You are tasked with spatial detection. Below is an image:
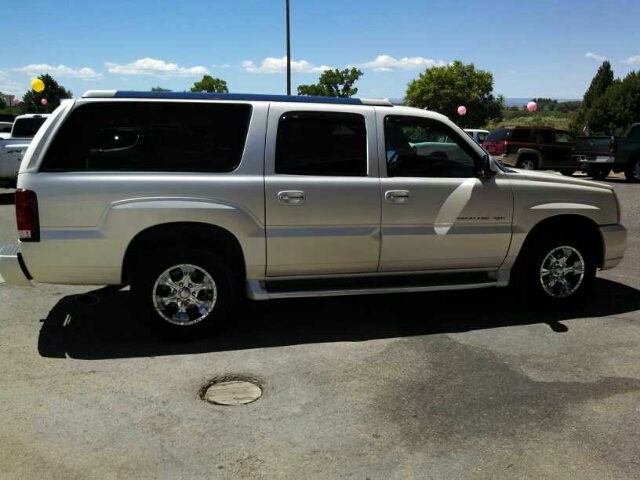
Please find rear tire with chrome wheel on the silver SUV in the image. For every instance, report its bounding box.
[131,245,236,340]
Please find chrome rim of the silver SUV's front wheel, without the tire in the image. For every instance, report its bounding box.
[540,246,586,298]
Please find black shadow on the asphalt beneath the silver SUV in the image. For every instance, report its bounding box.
[38,278,640,360]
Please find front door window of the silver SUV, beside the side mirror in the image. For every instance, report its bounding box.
[385,116,476,178]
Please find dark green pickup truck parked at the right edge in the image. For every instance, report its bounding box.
[575,123,640,182]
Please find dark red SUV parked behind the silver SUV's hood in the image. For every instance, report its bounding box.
[483,127,579,175]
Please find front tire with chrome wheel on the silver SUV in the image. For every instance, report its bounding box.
[512,232,596,308]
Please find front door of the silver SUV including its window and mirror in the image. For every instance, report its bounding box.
[378,113,513,271]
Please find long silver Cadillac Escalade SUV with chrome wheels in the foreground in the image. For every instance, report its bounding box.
[0,91,626,333]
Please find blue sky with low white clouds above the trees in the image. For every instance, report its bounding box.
[0,0,640,99]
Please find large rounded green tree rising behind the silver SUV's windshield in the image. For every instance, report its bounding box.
[405,61,504,127]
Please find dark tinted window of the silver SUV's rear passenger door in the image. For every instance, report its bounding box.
[275,112,367,176]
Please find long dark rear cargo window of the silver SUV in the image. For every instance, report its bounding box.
[41,102,251,172]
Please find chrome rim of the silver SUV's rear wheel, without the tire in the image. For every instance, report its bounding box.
[152,264,218,325]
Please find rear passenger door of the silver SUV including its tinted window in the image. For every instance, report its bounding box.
[265,104,380,276]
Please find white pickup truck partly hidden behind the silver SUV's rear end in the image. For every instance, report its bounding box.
[0,114,49,186]
